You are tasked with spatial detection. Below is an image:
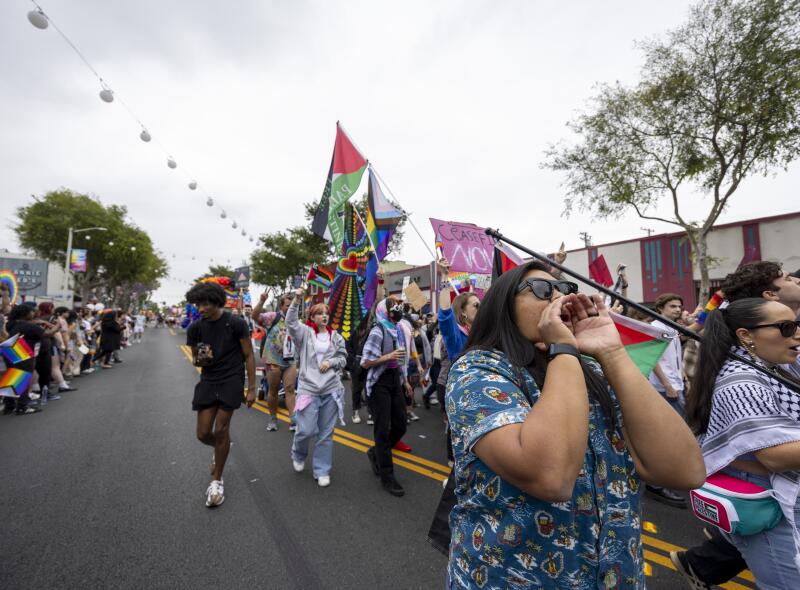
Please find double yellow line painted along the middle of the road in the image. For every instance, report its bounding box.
[180,345,755,590]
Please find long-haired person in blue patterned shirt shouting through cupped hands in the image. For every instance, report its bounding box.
[446,262,705,589]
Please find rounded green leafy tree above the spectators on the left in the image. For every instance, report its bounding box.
[14,189,168,307]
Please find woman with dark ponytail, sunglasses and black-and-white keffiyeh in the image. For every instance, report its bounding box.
[686,297,800,590]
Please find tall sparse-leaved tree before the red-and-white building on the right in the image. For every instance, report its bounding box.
[545,0,800,300]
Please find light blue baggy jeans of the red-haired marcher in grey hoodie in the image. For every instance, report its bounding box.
[292,395,339,478]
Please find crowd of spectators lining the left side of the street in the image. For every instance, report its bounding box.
[0,292,147,416]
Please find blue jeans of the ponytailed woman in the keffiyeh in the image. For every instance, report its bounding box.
[722,467,800,590]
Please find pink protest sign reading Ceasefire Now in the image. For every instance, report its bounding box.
[431,218,495,274]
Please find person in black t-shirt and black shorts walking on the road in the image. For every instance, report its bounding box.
[186,283,256,507]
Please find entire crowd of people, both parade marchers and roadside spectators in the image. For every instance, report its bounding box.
[15,253,784,589]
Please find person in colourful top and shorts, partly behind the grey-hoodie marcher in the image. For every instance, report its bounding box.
[253,293,297,431]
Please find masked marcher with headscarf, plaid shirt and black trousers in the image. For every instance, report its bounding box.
[361,297,411,497]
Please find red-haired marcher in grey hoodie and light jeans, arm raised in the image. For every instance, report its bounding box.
[286,289,347,488]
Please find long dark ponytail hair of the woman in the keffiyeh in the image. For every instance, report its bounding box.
[685,297,769,435]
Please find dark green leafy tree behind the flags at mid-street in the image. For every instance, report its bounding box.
[250,199,405,290]
